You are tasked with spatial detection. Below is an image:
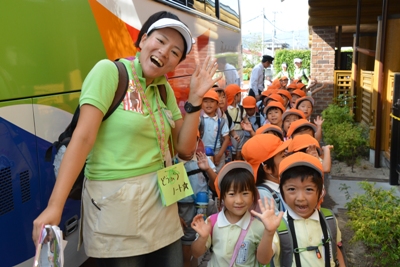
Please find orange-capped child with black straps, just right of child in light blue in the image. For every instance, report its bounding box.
[225,84,246,160]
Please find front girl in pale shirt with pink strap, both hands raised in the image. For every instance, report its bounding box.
[192,161,283,267]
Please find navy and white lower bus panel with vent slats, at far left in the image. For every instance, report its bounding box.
[0,99,41,266]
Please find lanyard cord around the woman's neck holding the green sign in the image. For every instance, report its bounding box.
[131,60,166,168]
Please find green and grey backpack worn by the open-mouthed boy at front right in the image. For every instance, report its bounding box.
[260,208,344,267]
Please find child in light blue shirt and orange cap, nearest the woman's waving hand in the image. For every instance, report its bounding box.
[199,90,230,172]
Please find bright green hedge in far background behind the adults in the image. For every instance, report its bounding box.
[274,49,311,77]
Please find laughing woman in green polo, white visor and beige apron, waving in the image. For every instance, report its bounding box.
[32,12,220,267]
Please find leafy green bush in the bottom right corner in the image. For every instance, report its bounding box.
[341,182,400,267]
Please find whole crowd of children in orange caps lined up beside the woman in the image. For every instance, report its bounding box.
[176,77,345,267]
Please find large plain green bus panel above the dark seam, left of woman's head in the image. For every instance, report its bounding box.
[0,0,106,101]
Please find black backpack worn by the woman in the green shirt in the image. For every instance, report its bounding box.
[45,61,167,200]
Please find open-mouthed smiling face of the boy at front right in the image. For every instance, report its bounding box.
[282,176,319,219]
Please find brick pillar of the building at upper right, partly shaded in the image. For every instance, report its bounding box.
[310,26,336,117]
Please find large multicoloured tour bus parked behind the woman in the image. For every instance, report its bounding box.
[0,0,242,267]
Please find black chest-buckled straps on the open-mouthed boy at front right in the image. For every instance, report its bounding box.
[287,212,331,267]
